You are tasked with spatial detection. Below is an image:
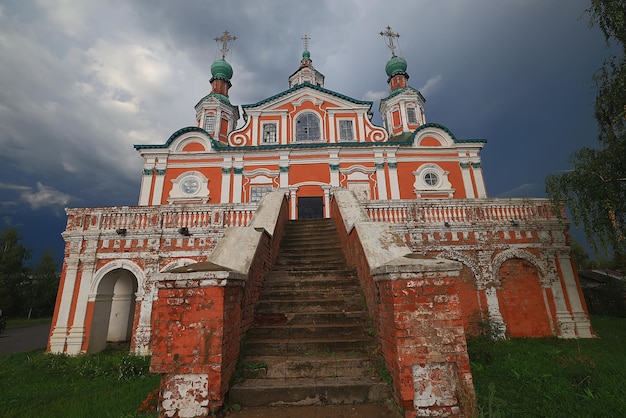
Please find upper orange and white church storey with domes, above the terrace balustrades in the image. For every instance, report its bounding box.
[135,29,486,219]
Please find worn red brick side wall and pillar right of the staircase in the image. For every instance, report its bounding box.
[331,200,474,418]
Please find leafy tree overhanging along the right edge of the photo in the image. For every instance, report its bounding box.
[546,0,626,258]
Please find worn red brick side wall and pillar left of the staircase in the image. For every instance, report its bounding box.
[150,199,288,410]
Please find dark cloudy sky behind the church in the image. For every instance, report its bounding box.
[0,0,608,258]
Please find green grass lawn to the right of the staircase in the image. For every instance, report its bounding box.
[468,317,626,418]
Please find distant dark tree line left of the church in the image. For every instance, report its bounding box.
[0,227,61,318]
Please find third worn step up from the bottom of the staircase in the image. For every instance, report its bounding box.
[241,336,376,356]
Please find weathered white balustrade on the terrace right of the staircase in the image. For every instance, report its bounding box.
[363,199,558,223]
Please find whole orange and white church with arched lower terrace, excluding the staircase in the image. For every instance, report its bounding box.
[48,28,592,354]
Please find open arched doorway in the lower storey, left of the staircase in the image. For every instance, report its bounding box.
[87,268,137,353]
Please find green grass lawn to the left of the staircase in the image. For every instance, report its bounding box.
[0,347,159,418]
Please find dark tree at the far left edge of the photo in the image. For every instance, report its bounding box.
[0,227,31,315]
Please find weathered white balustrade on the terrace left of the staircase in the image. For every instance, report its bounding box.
[66,203,257,231]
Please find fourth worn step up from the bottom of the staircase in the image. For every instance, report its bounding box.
[248,323,369,340]
